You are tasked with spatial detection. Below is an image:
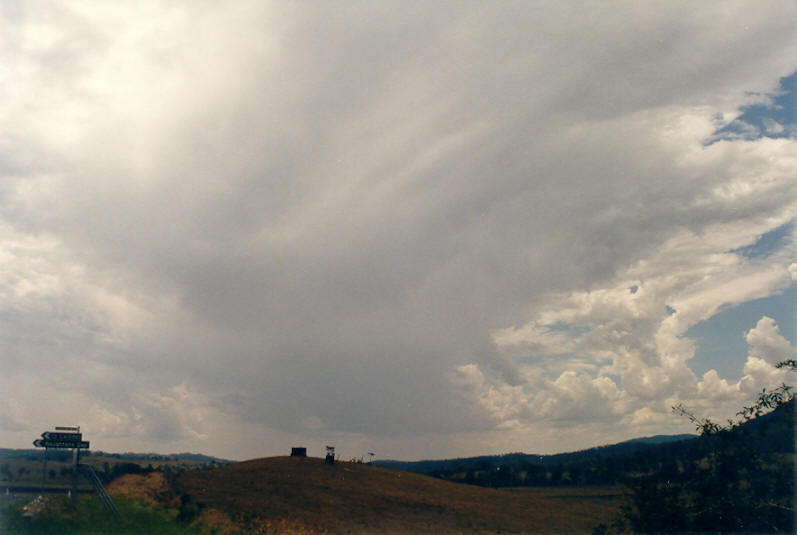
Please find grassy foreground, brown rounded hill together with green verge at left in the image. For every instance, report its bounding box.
[0,457,624,535]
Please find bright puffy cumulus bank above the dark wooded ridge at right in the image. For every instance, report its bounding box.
[470,206,793,440]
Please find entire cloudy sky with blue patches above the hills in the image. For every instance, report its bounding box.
[0,0,797,460]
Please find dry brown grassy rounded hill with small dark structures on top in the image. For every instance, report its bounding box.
[176,457,619,533]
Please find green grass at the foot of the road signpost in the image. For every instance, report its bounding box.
[0,496,201,535]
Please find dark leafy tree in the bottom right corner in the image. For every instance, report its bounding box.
[624,368,797,533]
